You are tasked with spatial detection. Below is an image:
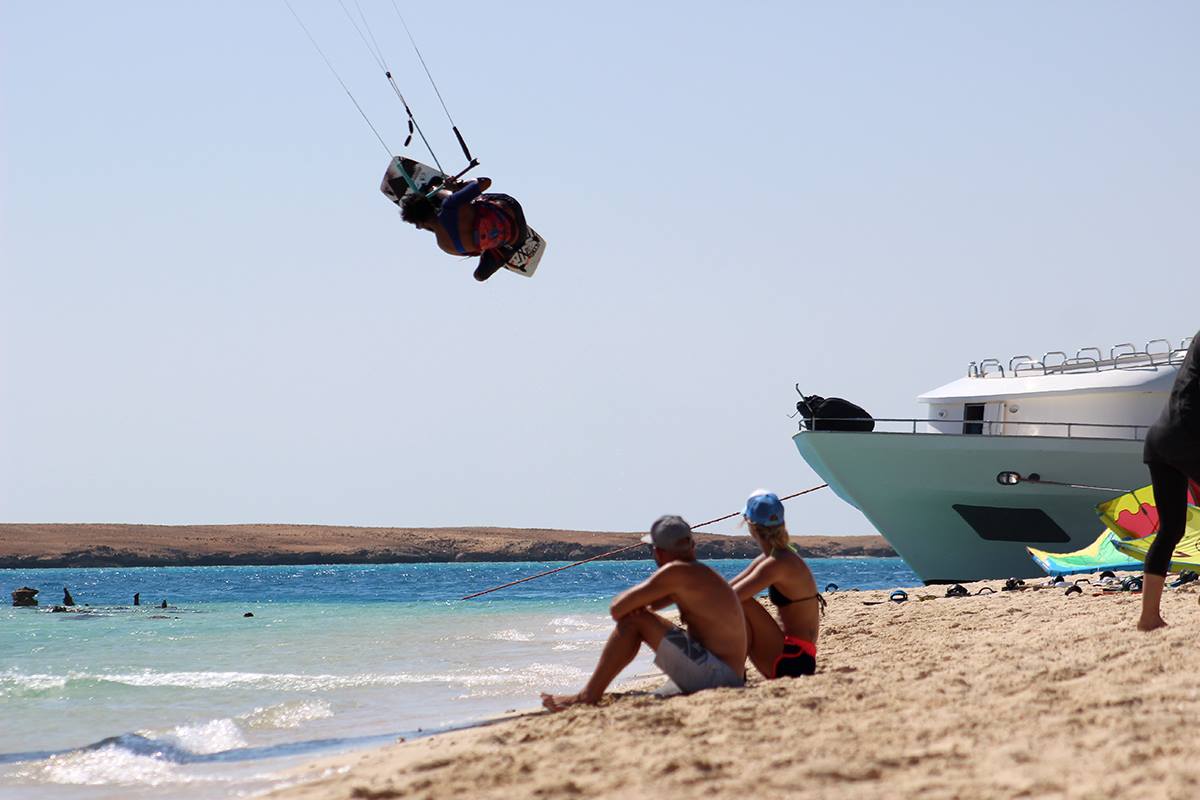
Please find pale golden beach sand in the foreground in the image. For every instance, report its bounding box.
[270,582,1200,800]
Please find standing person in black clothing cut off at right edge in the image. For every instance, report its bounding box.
[1138,333,1200,631]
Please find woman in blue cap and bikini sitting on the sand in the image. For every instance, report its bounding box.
[730,489,824,679]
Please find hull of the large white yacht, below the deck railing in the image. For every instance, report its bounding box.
[793,431,1150,583]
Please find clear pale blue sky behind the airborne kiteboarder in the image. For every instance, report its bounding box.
[0,0,1200,535]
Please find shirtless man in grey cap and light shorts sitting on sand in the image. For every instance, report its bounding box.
[541,516,746,711]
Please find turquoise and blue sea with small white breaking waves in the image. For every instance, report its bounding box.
[0,558,919,800]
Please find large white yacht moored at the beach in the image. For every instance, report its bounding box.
[793,339,1190,583]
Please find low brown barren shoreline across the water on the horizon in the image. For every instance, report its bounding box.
[0,523,895,570]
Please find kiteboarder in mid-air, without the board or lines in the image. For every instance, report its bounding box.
[400,178,529,281]
